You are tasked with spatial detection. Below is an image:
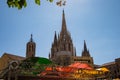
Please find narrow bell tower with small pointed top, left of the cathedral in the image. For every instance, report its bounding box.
[26,34,36,58]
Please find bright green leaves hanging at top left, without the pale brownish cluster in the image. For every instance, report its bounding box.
[7,0,53,9]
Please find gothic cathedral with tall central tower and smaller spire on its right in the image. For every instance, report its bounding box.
[49,10,94,66]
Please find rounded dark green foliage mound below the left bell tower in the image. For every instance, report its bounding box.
[19,57,53,75]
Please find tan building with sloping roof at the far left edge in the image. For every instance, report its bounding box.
[0,53,25,78]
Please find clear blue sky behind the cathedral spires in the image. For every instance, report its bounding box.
[0,0,120,65]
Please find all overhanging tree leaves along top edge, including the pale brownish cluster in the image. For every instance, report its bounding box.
[7,0,66,9]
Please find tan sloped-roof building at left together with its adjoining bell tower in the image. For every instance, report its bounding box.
[0,34,36,70]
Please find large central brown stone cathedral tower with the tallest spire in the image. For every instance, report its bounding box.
[49,10,76,65]
